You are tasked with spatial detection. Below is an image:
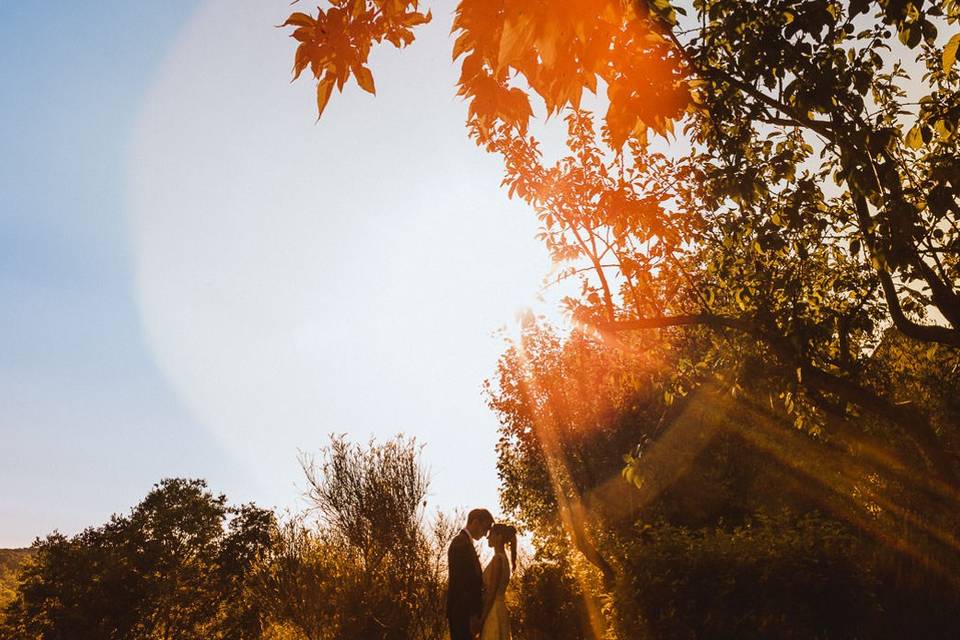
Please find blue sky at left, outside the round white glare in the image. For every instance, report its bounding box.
[0,2,248,546]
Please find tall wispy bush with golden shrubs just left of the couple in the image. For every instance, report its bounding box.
[255,437,455,640]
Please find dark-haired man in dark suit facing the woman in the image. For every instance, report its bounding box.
[447,509,493,640]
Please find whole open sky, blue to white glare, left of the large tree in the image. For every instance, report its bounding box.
[0,0,556,547]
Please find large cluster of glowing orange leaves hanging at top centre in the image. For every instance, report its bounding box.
[453,0,689,147]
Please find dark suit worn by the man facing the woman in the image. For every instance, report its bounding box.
[447,531,483,640]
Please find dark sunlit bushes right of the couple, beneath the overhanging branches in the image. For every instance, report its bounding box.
[488,326,960,638]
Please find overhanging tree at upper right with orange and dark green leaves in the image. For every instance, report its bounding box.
[289,0,960,552]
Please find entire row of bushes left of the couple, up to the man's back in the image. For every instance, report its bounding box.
[0,437,472,640]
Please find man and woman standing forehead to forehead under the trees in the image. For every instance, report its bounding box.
[447,509,517,640]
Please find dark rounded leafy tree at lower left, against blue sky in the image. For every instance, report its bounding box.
[3,479,273,640]
